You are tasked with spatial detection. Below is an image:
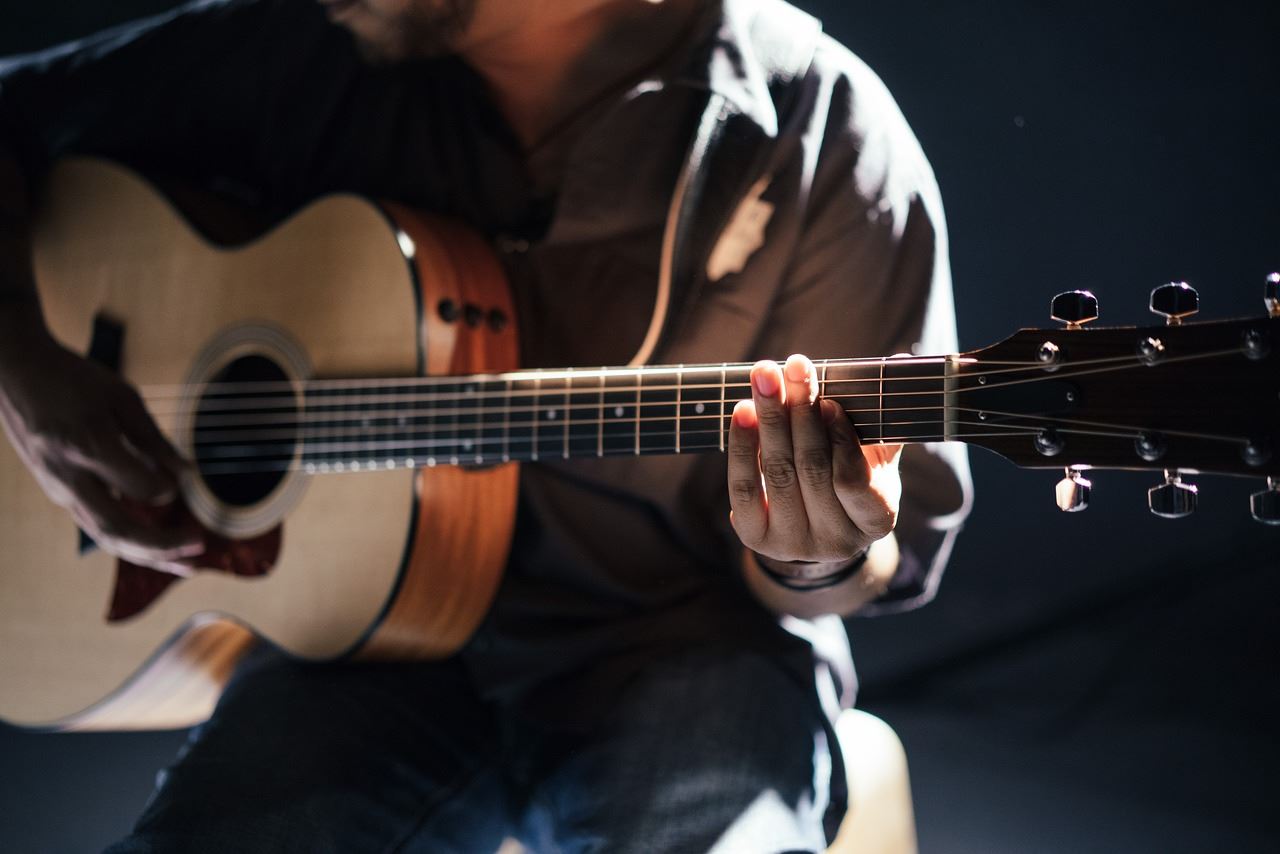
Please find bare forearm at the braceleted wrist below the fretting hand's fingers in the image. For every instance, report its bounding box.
[742,534,899,618]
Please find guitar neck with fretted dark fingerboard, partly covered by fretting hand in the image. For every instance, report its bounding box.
[288,357,950,472]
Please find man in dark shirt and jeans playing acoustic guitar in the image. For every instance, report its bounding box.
[0,0,969,851]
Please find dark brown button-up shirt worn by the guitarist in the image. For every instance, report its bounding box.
[0,0,968,695]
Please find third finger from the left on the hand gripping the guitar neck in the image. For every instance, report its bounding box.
[782,355,855,561]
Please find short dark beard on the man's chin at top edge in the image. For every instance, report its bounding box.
[339,0,476,65]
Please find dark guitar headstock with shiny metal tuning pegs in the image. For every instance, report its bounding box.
[947,274,1280,525]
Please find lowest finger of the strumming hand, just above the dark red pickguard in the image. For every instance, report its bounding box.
[72,472,204,566]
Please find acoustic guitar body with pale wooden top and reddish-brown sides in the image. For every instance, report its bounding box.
[0,160,517,729]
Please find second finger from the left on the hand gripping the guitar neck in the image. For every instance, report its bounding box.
[751,361,809,545]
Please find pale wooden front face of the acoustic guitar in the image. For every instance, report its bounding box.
[0,161,430,727]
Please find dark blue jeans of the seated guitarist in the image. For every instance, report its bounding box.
[108,648,844,854]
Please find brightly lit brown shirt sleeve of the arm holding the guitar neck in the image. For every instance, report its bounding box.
[762,40,972,615]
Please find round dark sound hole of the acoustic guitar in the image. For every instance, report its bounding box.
[195,355,298,507]
